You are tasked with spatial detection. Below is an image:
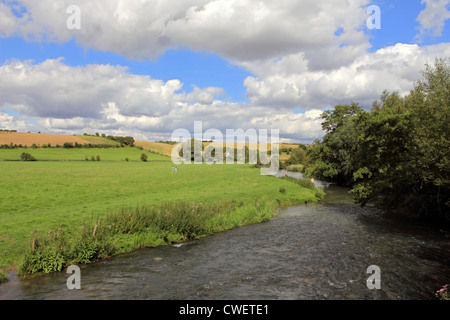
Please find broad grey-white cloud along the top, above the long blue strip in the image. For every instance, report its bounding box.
[0,0,368,63]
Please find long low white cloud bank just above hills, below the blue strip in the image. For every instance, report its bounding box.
[0,59,326,139]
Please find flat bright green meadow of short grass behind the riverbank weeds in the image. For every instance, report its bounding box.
[0,148,321,270]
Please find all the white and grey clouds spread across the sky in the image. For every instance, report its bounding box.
[0,0,450,141]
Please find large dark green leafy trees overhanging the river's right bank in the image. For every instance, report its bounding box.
[303,59,450,223]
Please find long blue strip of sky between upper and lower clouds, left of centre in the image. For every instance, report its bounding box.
[0,37,251,102]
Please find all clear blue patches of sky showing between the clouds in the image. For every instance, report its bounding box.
[0,0,442,102]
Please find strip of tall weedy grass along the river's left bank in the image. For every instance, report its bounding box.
[18,201,275,277]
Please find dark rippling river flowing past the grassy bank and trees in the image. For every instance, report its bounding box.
[0,173,450,300]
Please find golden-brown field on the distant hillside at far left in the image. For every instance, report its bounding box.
[0,131,89,147]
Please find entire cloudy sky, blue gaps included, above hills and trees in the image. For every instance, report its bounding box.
[0,0,450,140]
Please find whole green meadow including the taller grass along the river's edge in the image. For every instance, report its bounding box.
[0,148,321,273]
